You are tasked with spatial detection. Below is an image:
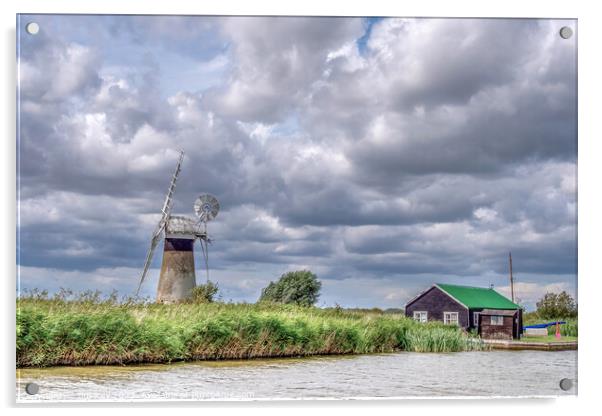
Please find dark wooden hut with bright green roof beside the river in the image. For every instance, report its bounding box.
[405,283,523,339]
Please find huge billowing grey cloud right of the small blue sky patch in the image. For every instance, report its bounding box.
[304,19,576,180]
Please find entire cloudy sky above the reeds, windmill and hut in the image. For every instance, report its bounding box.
[18,15,577,308]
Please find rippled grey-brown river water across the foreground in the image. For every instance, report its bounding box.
[16,351,577,402]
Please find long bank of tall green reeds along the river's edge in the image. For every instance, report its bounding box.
[17,296,484,367]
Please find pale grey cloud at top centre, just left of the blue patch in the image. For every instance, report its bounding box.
[208,17,363,122]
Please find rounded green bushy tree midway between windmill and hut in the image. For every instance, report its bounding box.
[259,270,322,306]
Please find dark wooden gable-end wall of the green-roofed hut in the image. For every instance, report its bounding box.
[406,287,469,328]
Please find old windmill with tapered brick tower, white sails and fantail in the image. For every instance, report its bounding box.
[136,151,219,303]
